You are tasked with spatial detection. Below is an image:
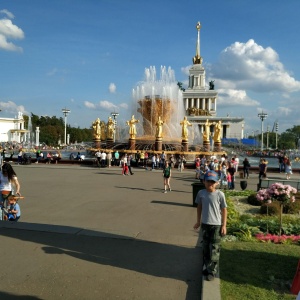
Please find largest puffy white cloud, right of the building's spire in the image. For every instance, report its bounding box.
[208,39,300,93]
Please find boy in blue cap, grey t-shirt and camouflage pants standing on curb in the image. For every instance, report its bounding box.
[194,171,227,281]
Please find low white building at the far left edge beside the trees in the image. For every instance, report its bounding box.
[0,112,28,143]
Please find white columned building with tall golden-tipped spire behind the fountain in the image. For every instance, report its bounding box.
[182,22,244,139]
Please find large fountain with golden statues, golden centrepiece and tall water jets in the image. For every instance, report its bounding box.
[88,66,224,160]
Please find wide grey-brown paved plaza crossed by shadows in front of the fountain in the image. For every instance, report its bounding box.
[0,164,290,300]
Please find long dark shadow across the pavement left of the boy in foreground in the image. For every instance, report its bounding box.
[0,222,202,300]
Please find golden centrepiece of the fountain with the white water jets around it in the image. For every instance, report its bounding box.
[132,66,184,142]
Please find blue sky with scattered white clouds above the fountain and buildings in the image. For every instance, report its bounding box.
[0,0,300,135]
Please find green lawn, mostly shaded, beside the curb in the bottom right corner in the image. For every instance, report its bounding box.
[220,242,300,300]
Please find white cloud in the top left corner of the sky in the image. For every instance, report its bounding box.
[0,13,24,52]
